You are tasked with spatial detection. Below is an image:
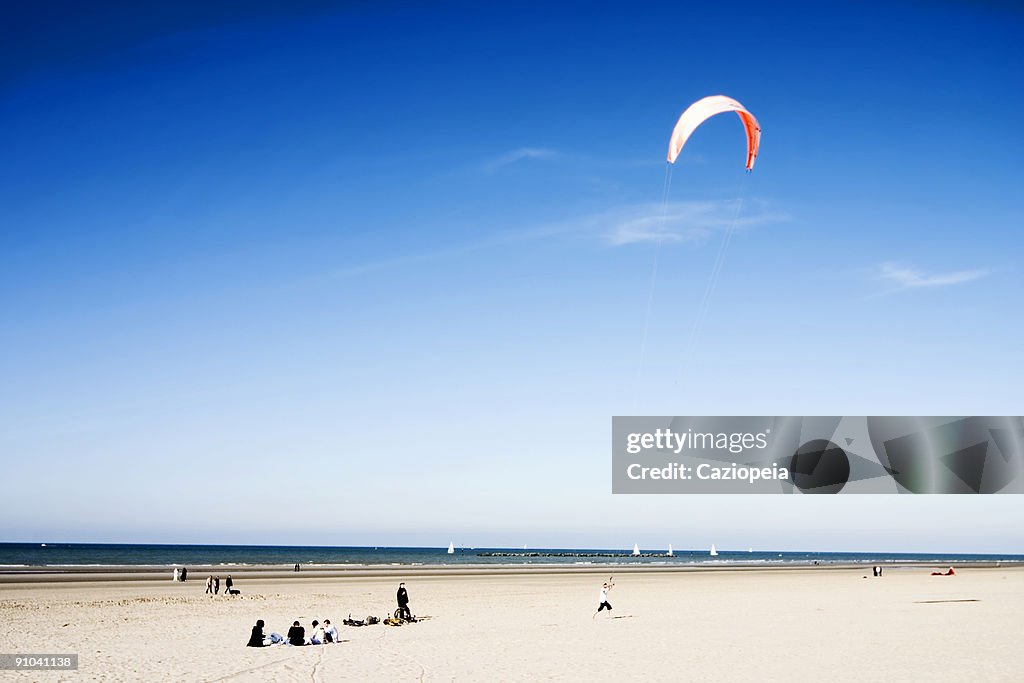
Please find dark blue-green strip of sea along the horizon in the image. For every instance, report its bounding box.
[0,543,1024,573]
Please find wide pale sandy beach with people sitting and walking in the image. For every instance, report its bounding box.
[0,566,1024,681]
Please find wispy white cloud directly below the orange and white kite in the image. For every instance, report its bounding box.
[604,201,791,247]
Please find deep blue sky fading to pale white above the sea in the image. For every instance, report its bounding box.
[0,2,1024,552]
